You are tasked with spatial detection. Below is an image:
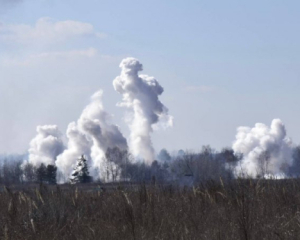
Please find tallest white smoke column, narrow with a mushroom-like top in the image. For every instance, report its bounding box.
[113,58,172,163]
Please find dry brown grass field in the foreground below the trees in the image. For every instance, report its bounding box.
[0,179,300,240]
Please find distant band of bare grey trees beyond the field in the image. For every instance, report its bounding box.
[0,146,300,185]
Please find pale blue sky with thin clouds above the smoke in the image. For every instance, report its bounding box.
[0,0,300,153]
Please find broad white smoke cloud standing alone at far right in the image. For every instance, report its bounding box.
[233,119,293,177]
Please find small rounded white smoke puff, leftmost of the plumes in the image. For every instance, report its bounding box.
[28,125,64,166]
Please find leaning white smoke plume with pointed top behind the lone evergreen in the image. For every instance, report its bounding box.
[56,90,127,178]
